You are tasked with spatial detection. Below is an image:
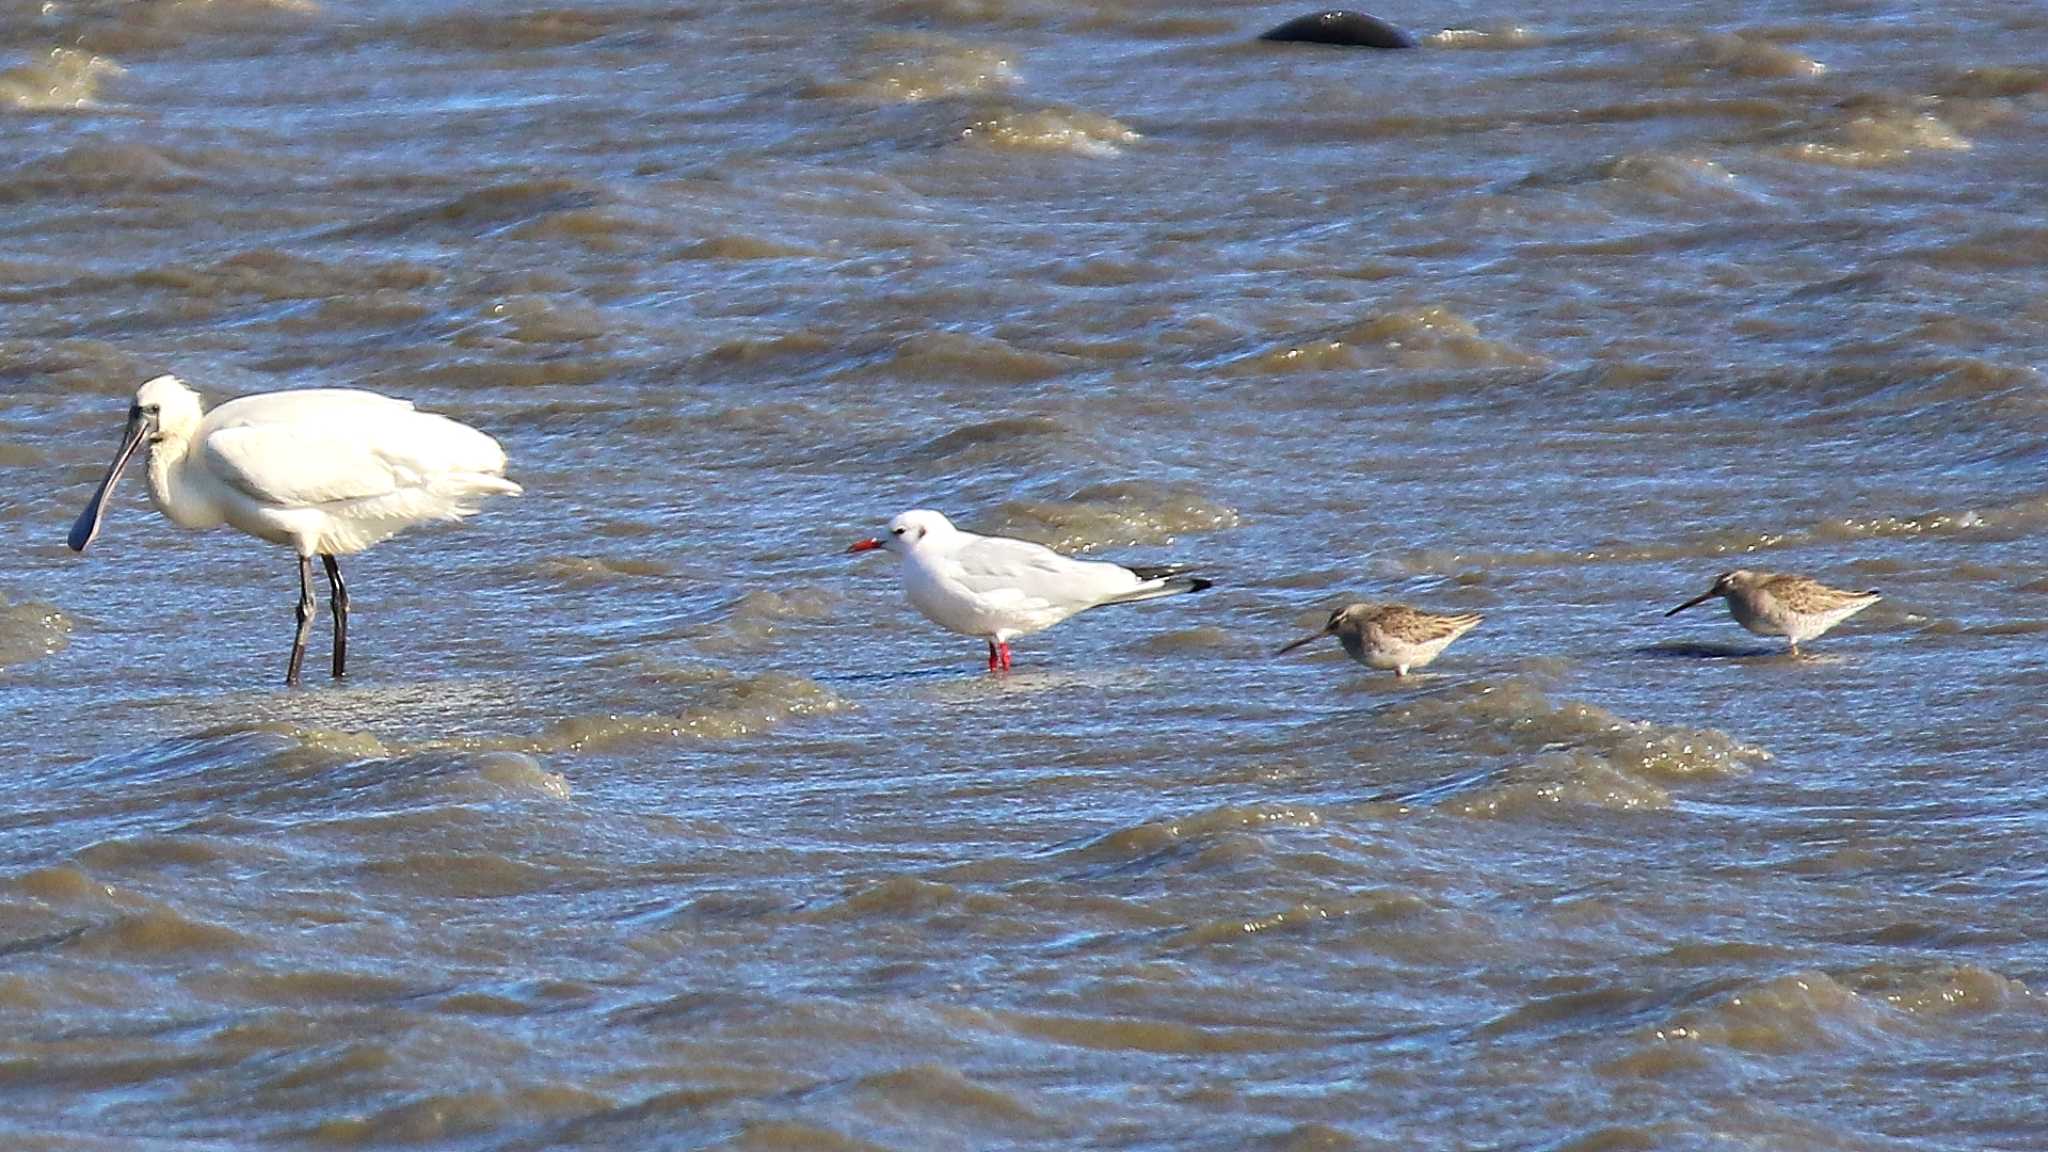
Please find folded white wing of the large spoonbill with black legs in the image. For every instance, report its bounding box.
[199,389,516,508]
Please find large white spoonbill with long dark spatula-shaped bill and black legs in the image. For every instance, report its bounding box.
[70,375,520,685]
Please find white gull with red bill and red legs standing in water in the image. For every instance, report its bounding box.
[846,508,1210,672]
